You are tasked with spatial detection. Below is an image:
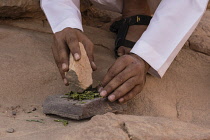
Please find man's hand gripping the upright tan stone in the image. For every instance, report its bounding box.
[52,27,97,85]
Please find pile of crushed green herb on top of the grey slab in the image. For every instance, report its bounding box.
[62,89,101,100]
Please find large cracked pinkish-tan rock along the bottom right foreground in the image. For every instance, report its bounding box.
[60,113,210,140]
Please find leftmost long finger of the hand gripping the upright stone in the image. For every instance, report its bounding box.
[56,41,69,72]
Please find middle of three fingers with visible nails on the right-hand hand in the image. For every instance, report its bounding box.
[108,77,138,102]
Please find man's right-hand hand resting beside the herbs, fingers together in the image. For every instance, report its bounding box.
[99,54,149,103]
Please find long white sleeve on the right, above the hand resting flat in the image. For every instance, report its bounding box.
[131,0,208,77]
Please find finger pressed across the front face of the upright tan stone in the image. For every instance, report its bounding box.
[66,33,81,61]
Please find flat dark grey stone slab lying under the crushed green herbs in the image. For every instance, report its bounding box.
[43,95,126,120]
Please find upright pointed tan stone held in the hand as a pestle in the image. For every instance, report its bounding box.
[65,43,93,92]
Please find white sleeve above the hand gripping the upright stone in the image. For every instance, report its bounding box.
[41,0,83,33]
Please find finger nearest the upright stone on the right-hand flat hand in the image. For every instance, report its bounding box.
[104,65,136,94]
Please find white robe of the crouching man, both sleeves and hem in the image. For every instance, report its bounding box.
[41,0,209,77]
